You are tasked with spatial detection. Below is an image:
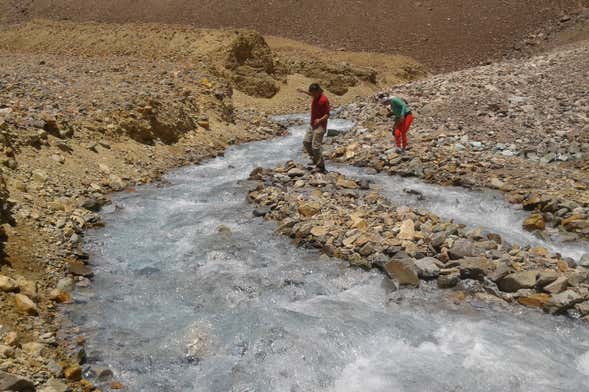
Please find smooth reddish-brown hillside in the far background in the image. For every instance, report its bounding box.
[0,0,589,70]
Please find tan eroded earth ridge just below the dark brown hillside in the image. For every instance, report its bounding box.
[0,21,425,98]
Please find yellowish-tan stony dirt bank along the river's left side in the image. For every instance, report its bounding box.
[0,21,425,391]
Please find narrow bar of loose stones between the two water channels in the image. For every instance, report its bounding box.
[248,162,589,321]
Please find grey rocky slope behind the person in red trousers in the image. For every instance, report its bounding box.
[328,45,589,241]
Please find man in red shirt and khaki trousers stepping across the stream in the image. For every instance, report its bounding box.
[297,83,331,173]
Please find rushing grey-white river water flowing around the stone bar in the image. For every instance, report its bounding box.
[68,118,589,392]
